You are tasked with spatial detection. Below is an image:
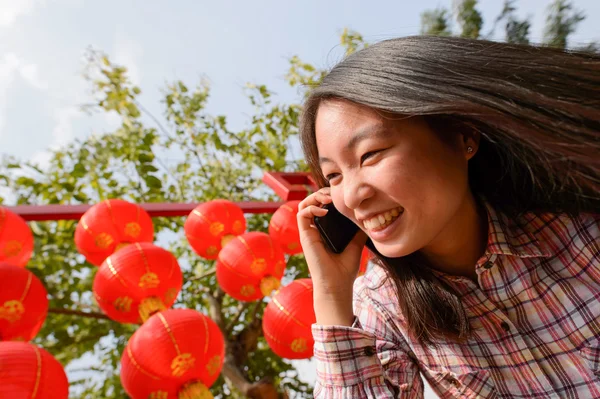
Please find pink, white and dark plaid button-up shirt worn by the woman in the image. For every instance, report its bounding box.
[312,206,600,399]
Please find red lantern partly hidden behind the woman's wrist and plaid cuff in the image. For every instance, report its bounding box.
[263,278,317,359]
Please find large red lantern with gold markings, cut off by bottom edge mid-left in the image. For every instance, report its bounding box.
[121,309,225,399]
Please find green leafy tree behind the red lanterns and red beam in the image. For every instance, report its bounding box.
[0,48,311,399]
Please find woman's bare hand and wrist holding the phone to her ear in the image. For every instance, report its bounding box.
[298,187,367,325]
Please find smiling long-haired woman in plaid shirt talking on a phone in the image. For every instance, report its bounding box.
[298,37,600,399]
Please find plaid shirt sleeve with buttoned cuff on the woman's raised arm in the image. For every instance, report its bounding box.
[312,287,423,399]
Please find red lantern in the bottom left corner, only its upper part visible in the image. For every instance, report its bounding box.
[0,342,69,399]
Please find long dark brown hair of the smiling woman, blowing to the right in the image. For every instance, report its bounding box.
[300,36,600,344]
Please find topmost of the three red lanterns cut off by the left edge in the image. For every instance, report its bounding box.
[0,206,33,267]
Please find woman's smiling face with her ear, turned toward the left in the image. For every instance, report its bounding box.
[315,100,476,257]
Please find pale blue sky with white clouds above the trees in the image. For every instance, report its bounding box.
[0,0,600,396]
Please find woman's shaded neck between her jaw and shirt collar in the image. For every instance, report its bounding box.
[421,193,488,281]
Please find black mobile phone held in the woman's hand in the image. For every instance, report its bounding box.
[313,202,358,254]
